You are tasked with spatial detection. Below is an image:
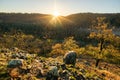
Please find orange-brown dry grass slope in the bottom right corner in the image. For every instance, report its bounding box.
[76,56,120,80]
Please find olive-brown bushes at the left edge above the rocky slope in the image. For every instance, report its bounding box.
[0,33,42,53]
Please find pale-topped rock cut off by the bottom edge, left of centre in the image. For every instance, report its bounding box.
[46,66,59,80]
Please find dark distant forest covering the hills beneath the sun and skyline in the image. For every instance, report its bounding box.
[0,13,120,42]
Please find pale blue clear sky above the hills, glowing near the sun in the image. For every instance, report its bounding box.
[0,0,120,15]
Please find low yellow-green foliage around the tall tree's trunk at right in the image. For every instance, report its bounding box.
[85,45,120,64]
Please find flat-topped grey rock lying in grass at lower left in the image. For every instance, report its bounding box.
[7,59,23,68]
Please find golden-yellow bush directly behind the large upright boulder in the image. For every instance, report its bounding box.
[51,37,80,55]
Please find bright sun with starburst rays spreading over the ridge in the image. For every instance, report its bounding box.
[42,0,75,27]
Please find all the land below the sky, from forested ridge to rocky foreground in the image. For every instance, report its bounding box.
[0,13,120,80]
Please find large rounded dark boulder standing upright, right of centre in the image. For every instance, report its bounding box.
[63,51,77,65]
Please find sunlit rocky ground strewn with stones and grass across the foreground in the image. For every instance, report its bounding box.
[0,48,120,80]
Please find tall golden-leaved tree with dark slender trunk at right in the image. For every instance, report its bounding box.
[89,17,114,67]
